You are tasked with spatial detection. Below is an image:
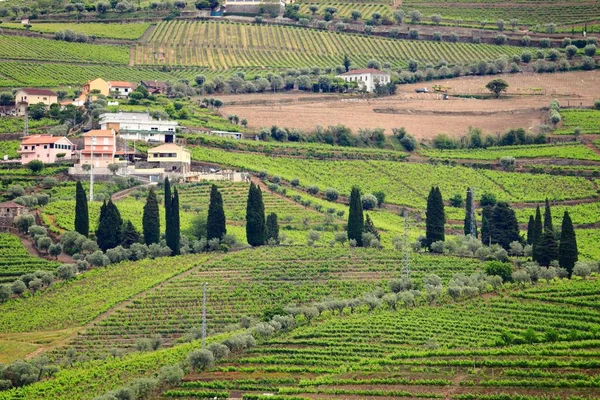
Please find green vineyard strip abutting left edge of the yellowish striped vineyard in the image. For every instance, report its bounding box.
[0,35,129,64]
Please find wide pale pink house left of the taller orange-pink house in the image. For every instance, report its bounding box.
[19,135,75,164]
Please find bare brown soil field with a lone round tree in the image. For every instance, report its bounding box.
[220,71,600,138]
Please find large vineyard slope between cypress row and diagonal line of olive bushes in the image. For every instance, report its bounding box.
[64,247,481,355]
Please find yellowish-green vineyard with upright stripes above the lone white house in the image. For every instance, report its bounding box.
[133,21,523,69]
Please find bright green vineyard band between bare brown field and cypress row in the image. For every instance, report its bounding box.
[192,147,596,209]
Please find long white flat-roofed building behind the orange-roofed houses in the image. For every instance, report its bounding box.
[100,111,179,143]
